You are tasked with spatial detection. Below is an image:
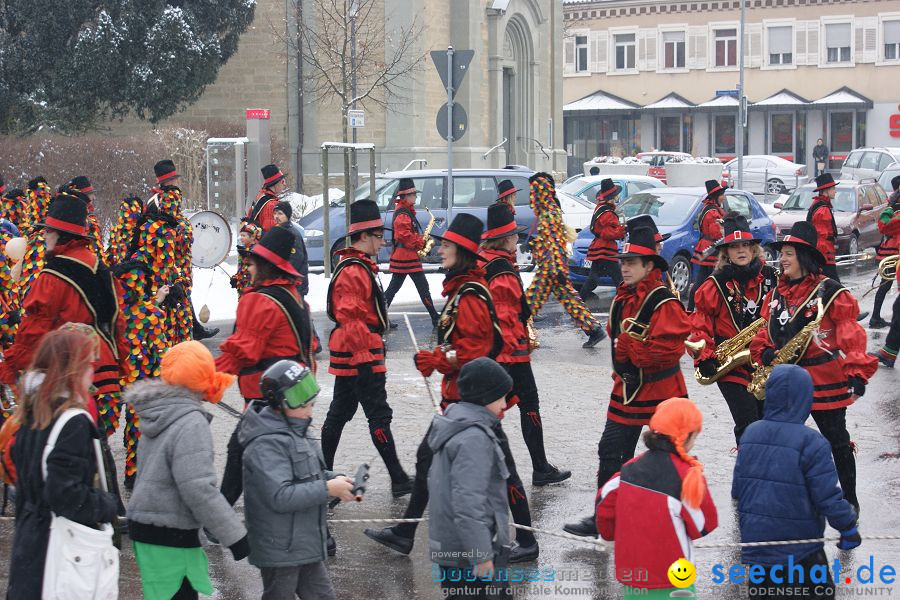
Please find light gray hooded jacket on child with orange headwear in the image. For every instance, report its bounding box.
[125,379,247,546]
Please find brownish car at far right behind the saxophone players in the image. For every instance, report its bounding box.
[772,180,887,255]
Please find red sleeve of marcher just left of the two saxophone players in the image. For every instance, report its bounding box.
[625,301,691,369]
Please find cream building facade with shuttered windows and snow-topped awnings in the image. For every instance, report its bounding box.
[563,0,900,173]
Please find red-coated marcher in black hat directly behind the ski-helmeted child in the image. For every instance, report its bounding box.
[216,227,316,504]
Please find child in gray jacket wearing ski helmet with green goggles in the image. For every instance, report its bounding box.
[238,360,354,600]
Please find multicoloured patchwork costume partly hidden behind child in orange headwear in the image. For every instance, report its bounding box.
[112,261,168,479]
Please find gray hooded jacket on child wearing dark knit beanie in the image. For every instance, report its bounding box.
[428,402,509,567]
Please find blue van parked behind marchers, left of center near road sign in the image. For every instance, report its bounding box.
[300,167,535,265]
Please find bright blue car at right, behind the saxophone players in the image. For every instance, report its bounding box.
[569,187,775,297]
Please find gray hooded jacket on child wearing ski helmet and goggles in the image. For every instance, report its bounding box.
[238,406,335,567]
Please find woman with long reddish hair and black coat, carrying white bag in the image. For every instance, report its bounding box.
[6,326,117,600]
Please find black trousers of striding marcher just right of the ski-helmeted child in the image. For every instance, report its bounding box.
[322,367,409,483]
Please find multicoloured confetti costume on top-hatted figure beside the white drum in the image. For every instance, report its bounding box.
[130,185,194,346]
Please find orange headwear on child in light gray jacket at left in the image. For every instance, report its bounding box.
[162,341,235,404]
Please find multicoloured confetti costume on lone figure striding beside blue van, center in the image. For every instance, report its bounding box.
[525,173,598,334]
